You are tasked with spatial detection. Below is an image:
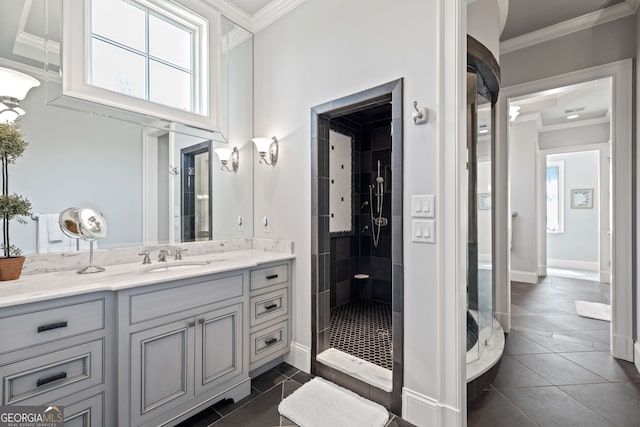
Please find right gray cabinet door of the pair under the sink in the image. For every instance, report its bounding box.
[196,304,243,393]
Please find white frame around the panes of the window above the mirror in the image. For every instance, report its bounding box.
[62,0,221,131]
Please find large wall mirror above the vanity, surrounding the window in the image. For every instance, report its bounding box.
[0,0,254,254]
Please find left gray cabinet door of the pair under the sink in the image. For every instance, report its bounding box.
[131,318,195,425]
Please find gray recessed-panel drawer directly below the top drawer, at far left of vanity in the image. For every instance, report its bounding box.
[0,340,104,405]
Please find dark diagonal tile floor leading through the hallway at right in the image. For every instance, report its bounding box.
[467,276,640,427]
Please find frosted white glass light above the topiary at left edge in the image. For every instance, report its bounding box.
[0,67,40,123]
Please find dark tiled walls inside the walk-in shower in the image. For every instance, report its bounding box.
[330,116,392,308]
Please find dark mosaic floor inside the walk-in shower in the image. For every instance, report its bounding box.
[329,299,393,370]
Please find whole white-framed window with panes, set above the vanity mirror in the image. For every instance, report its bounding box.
[63,0,220,130]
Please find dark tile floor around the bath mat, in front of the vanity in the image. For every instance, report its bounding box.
[177,363,413,427]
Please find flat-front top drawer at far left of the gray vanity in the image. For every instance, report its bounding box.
[0,299,105,353]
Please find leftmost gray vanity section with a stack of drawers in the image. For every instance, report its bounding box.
[0,292,115,427]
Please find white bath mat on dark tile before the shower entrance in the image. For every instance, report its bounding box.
[278,377,389,427]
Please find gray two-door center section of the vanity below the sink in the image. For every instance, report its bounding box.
[118,272,250,426]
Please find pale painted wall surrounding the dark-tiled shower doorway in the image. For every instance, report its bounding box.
[254,0,442,409]
